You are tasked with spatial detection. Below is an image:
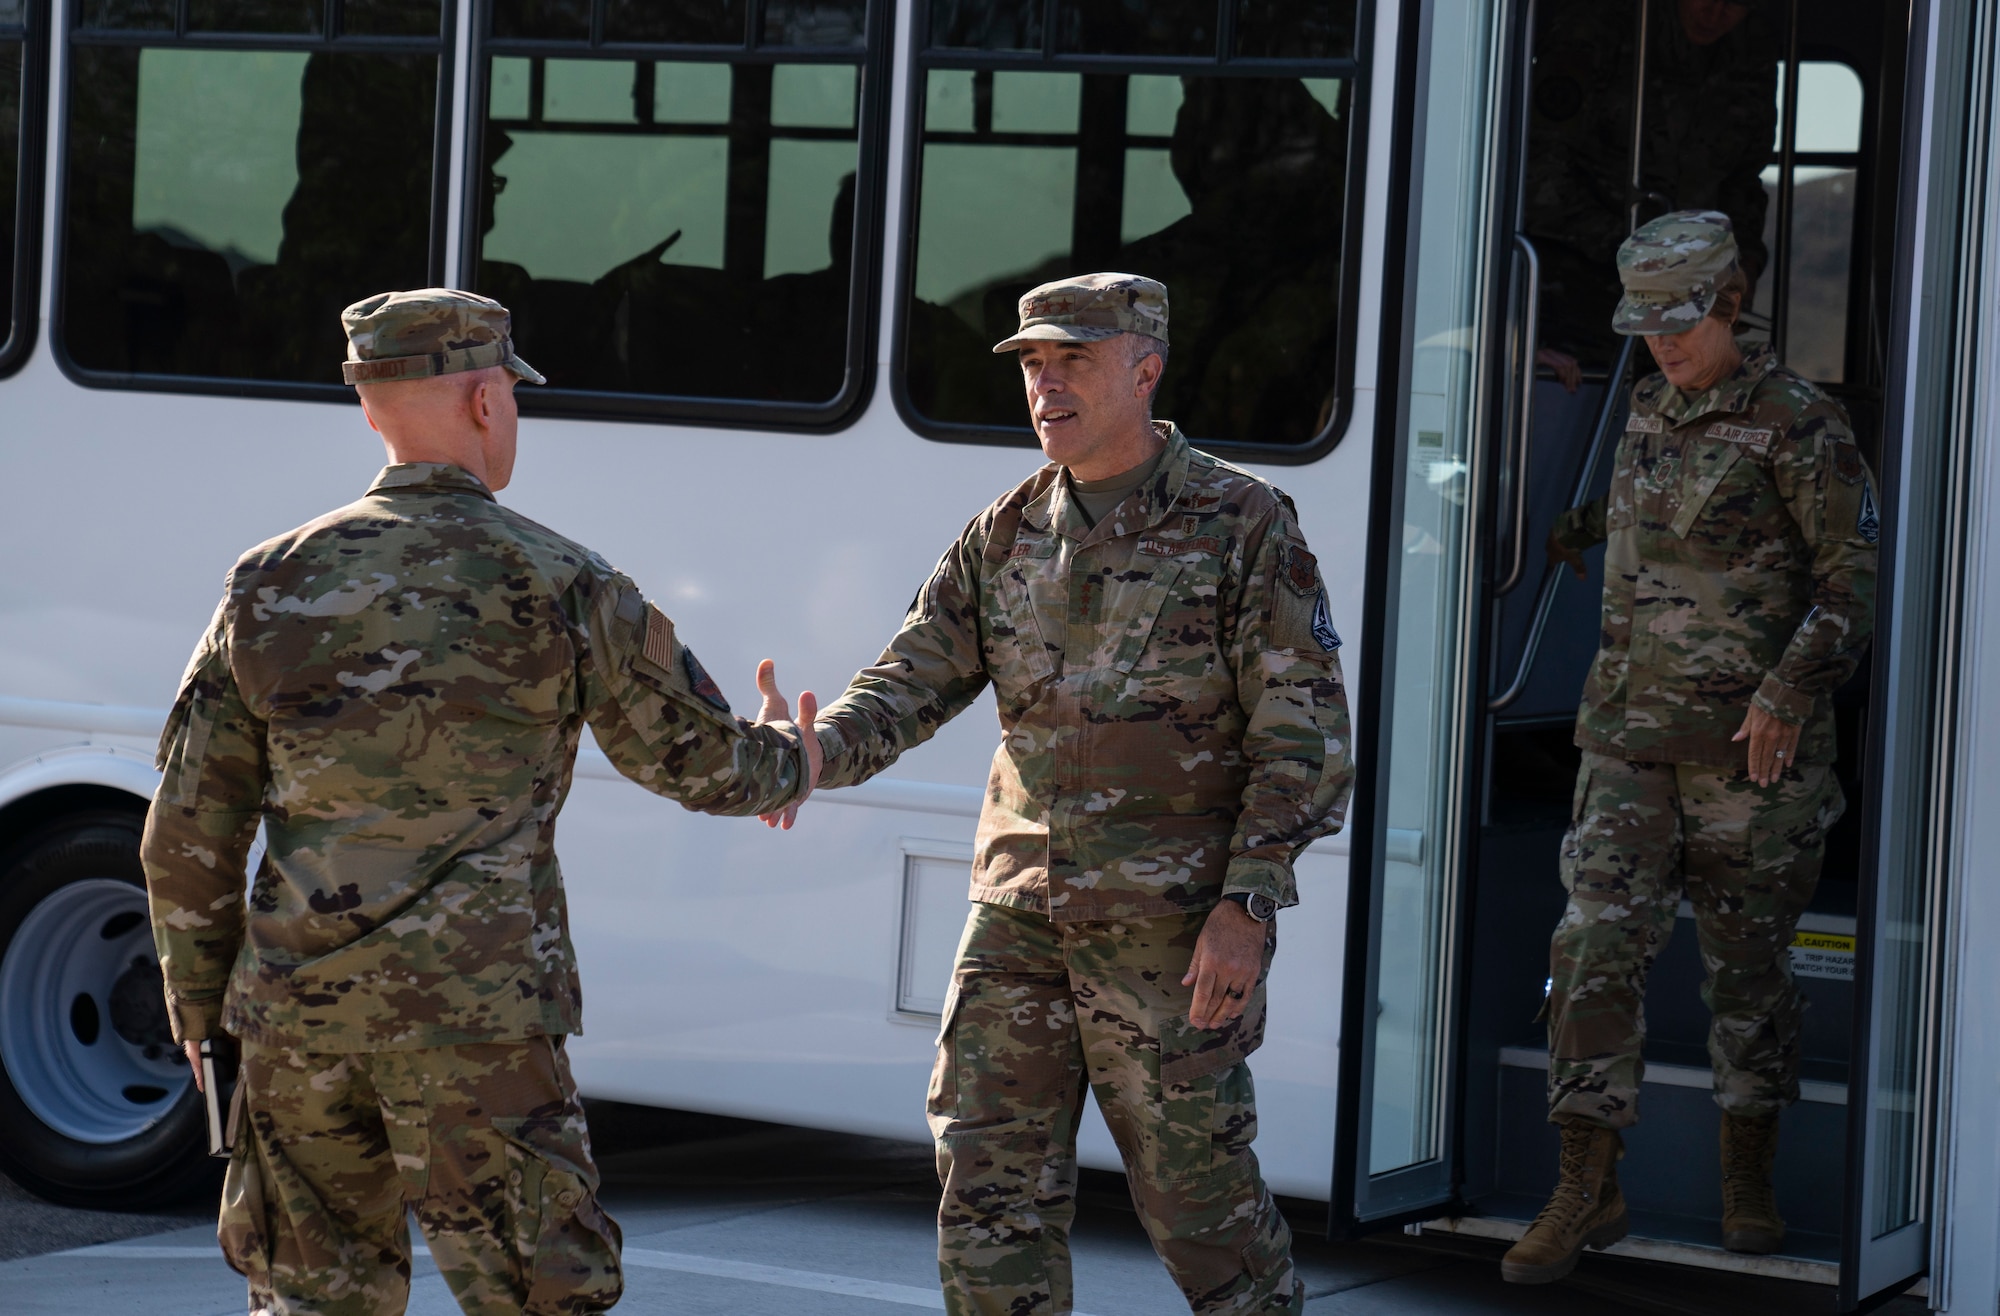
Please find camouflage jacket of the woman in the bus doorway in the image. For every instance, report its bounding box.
[1556,346,1882,768]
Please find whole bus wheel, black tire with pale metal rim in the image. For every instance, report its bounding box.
[0,808,220,1210]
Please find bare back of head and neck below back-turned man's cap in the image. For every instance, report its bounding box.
[354,366,520,492]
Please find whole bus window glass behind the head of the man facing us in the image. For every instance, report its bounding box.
[900,0,1362,456]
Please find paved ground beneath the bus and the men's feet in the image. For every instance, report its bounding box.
[0,1106,1924,1316]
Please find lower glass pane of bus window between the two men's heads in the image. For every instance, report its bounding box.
[478,58,860,402]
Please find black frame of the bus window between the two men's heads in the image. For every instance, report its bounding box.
[456,0,896,434]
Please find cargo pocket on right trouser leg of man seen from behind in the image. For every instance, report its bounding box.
[494,1118,624,1316]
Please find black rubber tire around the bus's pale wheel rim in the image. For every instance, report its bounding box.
[0,808,220,1210]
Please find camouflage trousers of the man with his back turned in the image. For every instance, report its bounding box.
[218,1038,624,1316]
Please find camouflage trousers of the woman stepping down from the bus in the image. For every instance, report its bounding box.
[1548,750,1844,1128]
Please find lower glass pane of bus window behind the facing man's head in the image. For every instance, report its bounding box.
[906,68,1350,444]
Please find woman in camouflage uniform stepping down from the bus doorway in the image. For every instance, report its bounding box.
[1506,210,1882,1282]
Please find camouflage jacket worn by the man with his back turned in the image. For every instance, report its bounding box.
[142,464,804,1052]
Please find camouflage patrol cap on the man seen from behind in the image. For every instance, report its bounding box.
[340,288,548,384]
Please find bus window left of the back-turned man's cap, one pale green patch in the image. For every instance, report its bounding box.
[56,0,442,392]
